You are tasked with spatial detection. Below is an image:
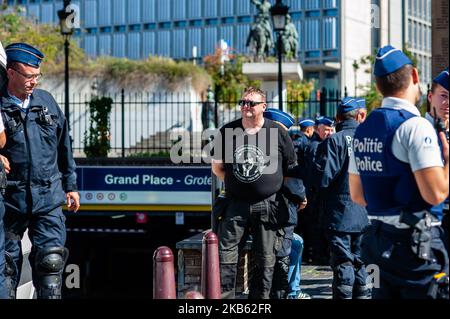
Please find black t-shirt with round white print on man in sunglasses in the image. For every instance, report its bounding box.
[214,119,296,202]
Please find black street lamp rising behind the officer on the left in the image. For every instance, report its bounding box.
[58,0,73,131]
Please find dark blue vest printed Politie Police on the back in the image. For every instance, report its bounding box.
[353,108,431,216]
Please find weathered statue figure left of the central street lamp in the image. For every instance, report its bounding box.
[247,0,274,61]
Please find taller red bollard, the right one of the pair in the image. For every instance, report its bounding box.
[202,231,222,299]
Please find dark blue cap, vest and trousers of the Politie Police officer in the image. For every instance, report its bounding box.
[353,46,448,299]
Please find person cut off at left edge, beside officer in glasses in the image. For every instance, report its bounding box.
[0,42,8,299]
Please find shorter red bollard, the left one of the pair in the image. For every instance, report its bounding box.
[153,246,177,299]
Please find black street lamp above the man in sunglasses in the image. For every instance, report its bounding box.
[270,0,289,110]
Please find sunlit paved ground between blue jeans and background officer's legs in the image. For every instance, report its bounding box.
[300,265,333,299]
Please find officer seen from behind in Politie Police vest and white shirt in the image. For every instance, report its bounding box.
[349,45,449,299]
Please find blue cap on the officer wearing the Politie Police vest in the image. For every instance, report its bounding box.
[373,45,413,76]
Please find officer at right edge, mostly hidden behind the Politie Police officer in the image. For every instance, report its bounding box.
[425,68,449,252]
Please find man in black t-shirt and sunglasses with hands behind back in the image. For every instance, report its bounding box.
[212,88,296,299]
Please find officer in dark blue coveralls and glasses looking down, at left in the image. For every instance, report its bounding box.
[0,43,80,299]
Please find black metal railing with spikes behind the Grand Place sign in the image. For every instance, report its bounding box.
[55,88,346,157]
